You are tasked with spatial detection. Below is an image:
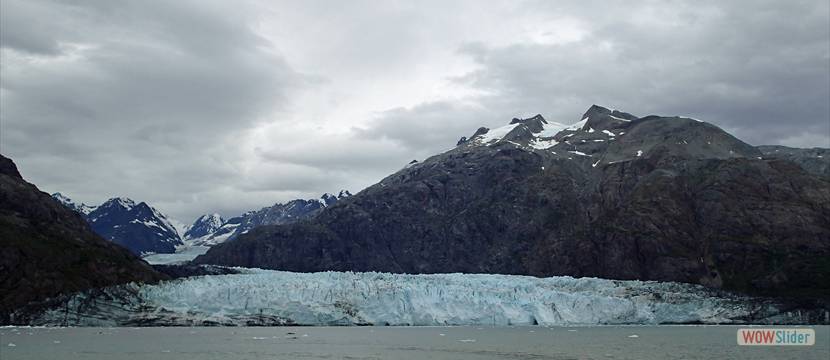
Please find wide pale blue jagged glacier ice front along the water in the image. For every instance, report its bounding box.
[24,269,776,326]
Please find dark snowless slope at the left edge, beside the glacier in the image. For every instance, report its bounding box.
[0,155,164,324]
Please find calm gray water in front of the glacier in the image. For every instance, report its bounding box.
[0,326,830,360]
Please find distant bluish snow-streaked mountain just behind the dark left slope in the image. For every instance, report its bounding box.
[52,193,183,255]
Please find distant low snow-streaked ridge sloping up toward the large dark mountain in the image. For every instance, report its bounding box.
[185,190,352,246]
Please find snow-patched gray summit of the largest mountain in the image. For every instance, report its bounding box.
[458,105,760,167]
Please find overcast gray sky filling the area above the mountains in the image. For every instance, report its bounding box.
[0,0,830,223]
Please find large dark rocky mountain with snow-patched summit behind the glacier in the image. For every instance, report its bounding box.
[195,106,830,298]
